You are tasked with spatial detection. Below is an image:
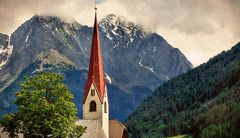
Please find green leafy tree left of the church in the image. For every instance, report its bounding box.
[2,72,85,138]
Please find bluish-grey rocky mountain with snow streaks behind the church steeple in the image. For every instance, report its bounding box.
[0,14,192,120]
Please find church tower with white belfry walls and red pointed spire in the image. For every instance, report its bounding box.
[83,8,109,138]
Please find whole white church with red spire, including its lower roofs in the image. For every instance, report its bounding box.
[76,8,128,138]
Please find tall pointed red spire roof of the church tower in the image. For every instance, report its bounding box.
[83,8,105,104]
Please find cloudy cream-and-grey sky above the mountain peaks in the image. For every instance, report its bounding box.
[0,0,240,67]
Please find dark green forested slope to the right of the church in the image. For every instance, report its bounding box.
[126,43,240,138]
